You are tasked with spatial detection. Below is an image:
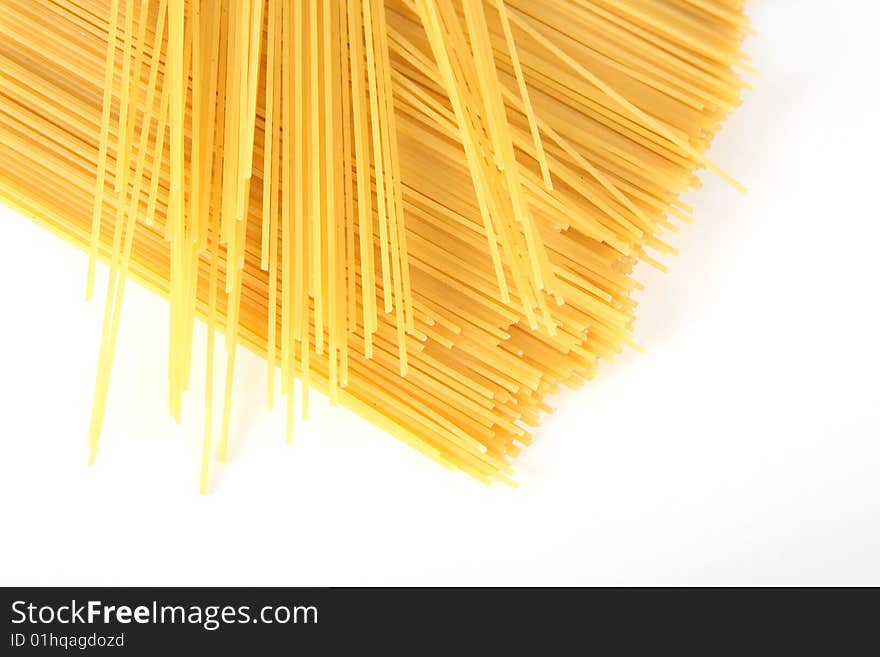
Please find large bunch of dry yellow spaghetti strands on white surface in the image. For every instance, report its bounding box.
[0,0,750,491]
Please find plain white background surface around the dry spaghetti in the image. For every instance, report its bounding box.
[0,0,880,585]
